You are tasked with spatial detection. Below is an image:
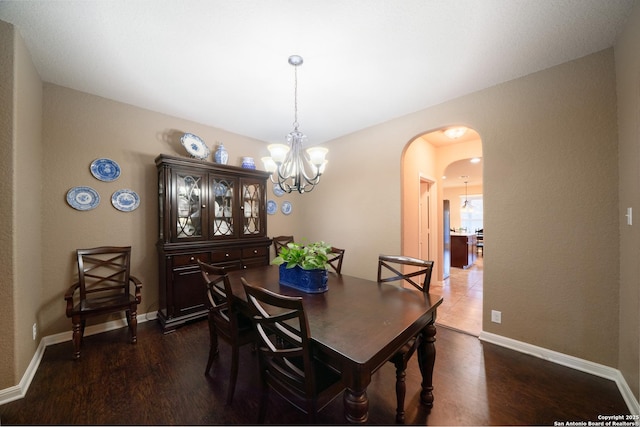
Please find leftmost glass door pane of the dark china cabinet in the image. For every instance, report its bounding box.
[175,172,202,239]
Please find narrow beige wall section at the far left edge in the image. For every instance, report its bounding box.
[0,22,42,389]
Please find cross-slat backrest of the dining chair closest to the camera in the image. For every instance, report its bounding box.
[241,277,316,400]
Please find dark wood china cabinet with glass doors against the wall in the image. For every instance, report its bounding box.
[156,154,271,331]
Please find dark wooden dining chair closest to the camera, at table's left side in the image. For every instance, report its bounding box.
[241,277,345,424]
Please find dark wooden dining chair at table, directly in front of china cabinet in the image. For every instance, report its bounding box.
[198,260,256,405]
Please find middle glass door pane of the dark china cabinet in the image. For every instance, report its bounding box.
[209,177,236,239]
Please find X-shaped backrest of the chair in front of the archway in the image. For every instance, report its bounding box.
[378,255,433,292]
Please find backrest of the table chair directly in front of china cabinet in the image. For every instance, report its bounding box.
[198,260,239,338]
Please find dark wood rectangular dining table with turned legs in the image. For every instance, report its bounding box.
[229,265,442,423]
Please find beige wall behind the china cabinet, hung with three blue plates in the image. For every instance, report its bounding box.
[40,84,266,335]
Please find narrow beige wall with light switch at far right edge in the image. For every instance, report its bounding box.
[615,1,640,398]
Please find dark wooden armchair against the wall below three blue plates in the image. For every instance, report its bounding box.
[64,246,142,360]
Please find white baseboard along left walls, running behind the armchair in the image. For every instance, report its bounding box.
[0,312,157,405]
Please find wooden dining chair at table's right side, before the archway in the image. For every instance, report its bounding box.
[378,255,433,424]
